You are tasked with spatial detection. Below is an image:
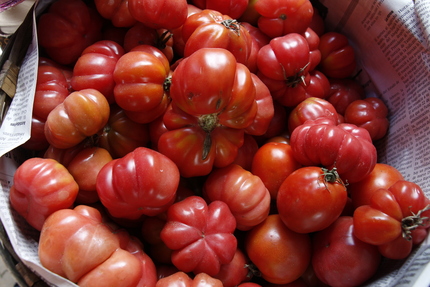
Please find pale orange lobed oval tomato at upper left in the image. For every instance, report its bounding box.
[45,89,110,149]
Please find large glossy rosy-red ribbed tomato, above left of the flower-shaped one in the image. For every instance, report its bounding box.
[96,147,179,220]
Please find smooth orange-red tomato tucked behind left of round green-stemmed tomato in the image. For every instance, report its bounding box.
[251,142,301,200]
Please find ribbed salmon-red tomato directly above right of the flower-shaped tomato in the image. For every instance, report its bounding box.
[203,164,270,230]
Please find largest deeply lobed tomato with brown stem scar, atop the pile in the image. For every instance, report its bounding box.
[158,48,263,177]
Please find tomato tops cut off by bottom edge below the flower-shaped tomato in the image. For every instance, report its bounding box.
[155,271,223,287]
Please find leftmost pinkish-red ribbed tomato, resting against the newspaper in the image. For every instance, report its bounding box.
[9,158,79,231]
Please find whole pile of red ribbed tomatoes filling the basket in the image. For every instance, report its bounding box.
[10,0,430,287]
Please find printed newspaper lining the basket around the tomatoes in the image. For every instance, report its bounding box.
[0,0,430,287]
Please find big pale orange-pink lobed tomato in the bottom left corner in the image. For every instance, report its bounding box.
[38,205,156,287]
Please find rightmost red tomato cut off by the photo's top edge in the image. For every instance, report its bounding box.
[254,0,314,38]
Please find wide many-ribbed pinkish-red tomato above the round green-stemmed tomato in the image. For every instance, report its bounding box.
[290,118,377,183]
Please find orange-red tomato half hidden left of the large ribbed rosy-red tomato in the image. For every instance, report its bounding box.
[67,147,112,204]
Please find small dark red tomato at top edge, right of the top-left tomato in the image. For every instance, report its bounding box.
[94,0,137,27]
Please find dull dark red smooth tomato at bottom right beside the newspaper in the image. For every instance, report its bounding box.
[312,216,381,286]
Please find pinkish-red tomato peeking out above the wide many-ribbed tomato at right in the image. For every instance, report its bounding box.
[288,97,338,133]
